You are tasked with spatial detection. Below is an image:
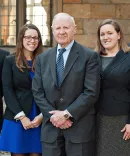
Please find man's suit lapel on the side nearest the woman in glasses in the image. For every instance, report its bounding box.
[50,47,58,87]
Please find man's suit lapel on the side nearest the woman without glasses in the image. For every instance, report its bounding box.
[62,42,79,83]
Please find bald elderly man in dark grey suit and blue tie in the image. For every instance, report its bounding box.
[32,13,99,156]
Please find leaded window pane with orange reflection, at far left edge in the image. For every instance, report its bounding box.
[0,0,16,46]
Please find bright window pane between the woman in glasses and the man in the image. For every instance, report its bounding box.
[26,0,50,46]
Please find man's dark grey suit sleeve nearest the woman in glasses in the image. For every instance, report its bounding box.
[32,56,55,118]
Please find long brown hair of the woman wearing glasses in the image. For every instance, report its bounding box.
[15,24,43,72]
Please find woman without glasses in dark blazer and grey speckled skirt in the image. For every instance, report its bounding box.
[96,19,130,156]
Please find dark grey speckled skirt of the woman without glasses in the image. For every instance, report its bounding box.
[95,114,130,156]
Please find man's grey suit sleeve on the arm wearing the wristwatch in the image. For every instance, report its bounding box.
[67,53,100,120]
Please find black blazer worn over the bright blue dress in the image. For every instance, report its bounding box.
[2,55,33,120]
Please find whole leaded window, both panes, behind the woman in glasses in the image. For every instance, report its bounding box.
[0,0,51,46]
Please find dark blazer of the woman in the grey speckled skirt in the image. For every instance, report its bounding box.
[96,50,130,123]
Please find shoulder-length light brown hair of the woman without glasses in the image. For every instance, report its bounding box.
[95,19,130,55]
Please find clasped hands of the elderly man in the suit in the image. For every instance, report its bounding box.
[49,110,72,129]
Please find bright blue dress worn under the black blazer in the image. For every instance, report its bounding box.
[0,61,42,154]
